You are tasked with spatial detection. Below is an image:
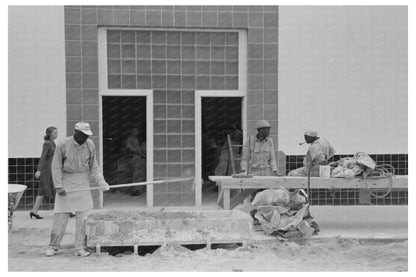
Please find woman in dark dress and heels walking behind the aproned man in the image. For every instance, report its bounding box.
[30,126,58,219]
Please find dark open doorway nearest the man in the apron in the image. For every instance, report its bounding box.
[102,96,146,199]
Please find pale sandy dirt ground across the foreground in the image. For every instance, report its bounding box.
[9,207,408,271]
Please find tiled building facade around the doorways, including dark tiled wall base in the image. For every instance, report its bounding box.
[9,6,408,209]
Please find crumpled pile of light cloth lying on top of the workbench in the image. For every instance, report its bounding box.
[329,152,376,179]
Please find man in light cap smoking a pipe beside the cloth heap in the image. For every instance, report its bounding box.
[288,129,335,177]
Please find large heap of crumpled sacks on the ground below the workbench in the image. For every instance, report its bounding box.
[251,187,319,238]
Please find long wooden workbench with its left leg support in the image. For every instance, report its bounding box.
[209,176,408,210]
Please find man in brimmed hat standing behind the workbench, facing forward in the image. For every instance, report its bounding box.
[241,120,279,176]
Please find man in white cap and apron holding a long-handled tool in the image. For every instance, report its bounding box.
[46,122,109,257]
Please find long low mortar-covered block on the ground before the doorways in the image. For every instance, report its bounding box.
[87,208,253,246]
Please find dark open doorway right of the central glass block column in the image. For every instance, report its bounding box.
[201,97,243,200]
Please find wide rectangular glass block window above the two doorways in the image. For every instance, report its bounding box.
[107,30,238,90]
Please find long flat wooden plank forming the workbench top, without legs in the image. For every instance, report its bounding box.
[209,176,408,189]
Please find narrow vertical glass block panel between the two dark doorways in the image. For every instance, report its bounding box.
[153,90,195,179]
